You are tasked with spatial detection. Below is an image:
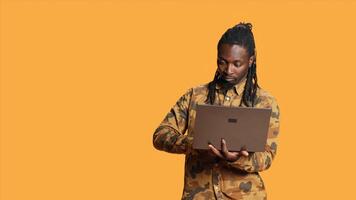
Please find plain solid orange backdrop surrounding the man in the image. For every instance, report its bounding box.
[1,0,356,200]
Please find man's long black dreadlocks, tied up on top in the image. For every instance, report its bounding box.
[205,22,260,107]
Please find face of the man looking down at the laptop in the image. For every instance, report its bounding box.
[217,44,254,84]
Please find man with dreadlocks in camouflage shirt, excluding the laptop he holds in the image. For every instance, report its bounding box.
[153,23,279,199]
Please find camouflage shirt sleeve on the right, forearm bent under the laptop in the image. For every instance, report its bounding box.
[224,98,279,173]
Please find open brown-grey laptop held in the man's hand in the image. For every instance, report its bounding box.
[193,104,272,152]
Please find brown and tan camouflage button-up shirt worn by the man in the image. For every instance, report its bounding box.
[153,78,279,200]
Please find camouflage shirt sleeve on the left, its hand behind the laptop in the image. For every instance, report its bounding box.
[153,88,193,154]
